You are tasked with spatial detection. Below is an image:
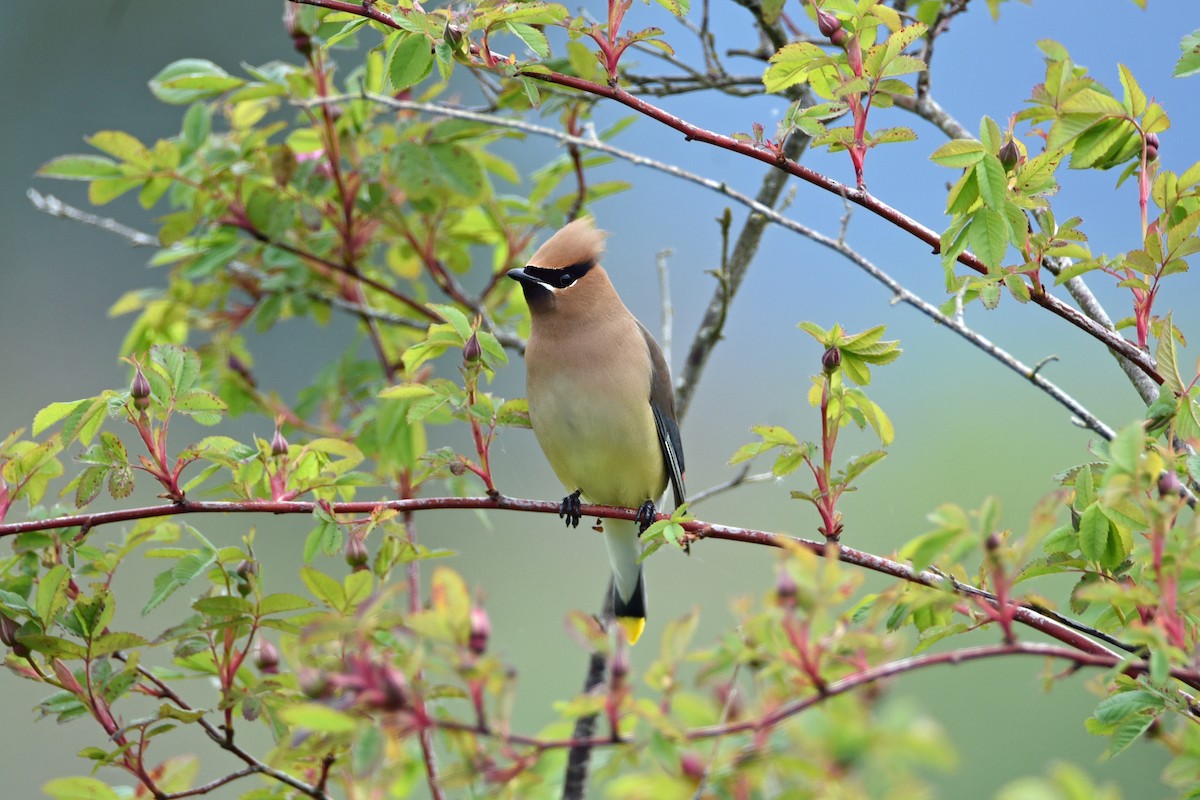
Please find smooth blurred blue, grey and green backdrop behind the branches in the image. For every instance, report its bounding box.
[0,0,1200,798]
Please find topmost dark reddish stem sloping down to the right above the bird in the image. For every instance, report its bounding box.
[290,0,1163,384]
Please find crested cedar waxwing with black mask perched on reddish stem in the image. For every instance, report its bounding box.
[509,218,684,644]
